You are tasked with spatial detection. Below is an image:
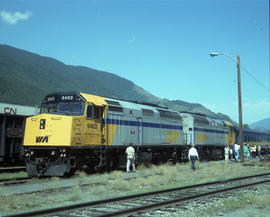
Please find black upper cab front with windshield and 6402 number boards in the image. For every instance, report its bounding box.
[40,94,85,115]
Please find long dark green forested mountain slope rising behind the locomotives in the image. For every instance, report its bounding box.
[0,45,231,121]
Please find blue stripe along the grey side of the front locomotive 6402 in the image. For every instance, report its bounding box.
[102,118,183,130]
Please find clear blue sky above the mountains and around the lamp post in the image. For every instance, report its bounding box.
[0,0,270,124]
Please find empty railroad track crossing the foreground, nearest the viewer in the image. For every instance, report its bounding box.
[5,173,270,217]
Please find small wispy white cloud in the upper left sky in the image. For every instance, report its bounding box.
[0,11,32,25]
